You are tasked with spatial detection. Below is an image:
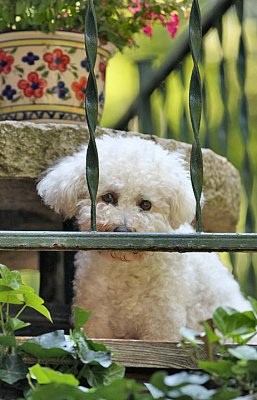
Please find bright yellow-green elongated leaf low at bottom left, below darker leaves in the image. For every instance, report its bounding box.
[29,364,79,386]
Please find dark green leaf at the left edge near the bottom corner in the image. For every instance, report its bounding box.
[0,355,28,385]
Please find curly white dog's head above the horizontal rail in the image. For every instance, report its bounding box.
[38,136,195,260]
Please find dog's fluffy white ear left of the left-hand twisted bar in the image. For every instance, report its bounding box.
[37,146,87,218]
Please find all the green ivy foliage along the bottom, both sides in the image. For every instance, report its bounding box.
[0,265,257,400]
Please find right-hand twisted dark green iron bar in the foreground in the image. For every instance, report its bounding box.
[189,0,203,232]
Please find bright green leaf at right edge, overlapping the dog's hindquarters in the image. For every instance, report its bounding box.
[213,307,256,338]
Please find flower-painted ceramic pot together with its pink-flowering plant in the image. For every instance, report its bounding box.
[0,0,191,122]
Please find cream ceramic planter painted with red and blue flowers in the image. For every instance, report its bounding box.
[0,31,114,123]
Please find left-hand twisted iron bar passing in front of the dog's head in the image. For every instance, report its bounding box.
[85,0,99,231]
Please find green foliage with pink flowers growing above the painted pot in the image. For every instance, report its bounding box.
[0,0,192,49]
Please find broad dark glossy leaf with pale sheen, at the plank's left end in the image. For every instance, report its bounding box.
[19,330,75,359]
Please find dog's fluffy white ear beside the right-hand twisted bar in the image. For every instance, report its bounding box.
[165,153,199,229]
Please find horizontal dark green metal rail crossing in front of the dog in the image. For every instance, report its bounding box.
[0,231,257,253]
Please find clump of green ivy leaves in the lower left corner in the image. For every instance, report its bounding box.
[0,265,124,396]
